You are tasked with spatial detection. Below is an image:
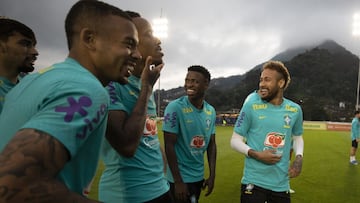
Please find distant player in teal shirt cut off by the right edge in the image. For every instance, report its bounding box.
[350,111,360,165]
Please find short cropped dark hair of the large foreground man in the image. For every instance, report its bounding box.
[65,0,132,50]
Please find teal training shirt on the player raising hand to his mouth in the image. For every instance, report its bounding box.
[99,76,169,203]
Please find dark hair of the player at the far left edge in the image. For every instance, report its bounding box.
[0,16,36,44]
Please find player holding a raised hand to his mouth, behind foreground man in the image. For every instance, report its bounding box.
[99,11,172,203]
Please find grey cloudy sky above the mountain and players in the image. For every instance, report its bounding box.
[0,0,360,89]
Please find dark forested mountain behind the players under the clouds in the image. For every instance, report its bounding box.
[156,40,359,121]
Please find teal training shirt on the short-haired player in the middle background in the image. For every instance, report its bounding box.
[162,96,216,183]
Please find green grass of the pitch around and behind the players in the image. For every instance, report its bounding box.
[90,126,360,203]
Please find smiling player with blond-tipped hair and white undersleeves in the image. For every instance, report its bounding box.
[231,61,304,203]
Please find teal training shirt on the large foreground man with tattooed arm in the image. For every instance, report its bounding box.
[0,58,109,194]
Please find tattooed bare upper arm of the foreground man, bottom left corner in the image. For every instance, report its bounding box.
[0,129,90,202]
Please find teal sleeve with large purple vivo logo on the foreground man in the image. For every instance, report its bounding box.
[22,82,109,157]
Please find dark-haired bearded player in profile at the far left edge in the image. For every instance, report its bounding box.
[0,17,39,113]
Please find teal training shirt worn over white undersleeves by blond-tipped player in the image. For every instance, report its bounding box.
[234,92,303,192]
